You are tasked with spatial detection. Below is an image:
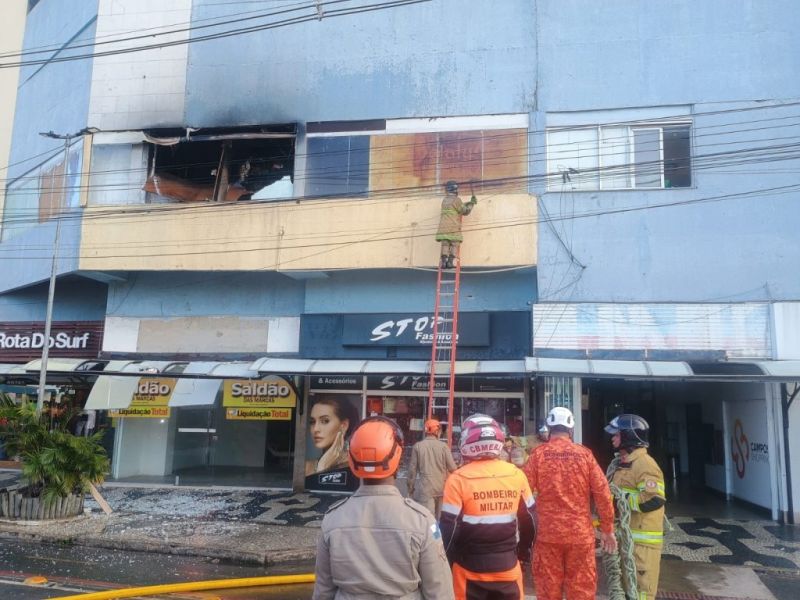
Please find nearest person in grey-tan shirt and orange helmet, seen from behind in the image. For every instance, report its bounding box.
[313,417,453,600]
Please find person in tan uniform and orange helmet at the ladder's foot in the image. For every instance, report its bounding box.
[408,419,456,520]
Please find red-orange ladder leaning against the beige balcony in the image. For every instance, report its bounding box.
[428,244,461,446]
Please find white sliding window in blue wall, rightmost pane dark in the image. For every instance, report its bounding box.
[547,123,692,190]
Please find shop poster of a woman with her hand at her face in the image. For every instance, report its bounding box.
[306,394,361,492]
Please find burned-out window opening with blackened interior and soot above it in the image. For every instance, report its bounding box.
[143,126,295,202]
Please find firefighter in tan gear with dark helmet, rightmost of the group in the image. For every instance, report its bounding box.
[605,415,666,600]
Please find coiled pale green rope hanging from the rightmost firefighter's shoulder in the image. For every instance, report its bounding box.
[601,456,638,600]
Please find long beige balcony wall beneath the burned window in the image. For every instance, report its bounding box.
[78,193,537,272]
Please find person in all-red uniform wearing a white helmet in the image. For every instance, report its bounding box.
[523,407,617,600]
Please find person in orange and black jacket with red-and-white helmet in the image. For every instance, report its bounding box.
[440,415,534,600]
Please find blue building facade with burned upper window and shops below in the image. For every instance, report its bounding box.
[0,0,800,520]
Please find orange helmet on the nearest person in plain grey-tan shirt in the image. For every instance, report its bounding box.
[348,417,403,479]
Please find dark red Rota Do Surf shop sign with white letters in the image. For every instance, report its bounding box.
[0,321,103,361]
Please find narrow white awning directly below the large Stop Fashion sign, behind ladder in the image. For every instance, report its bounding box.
[250,357,525,375]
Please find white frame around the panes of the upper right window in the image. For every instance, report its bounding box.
[545,123,695,192]
